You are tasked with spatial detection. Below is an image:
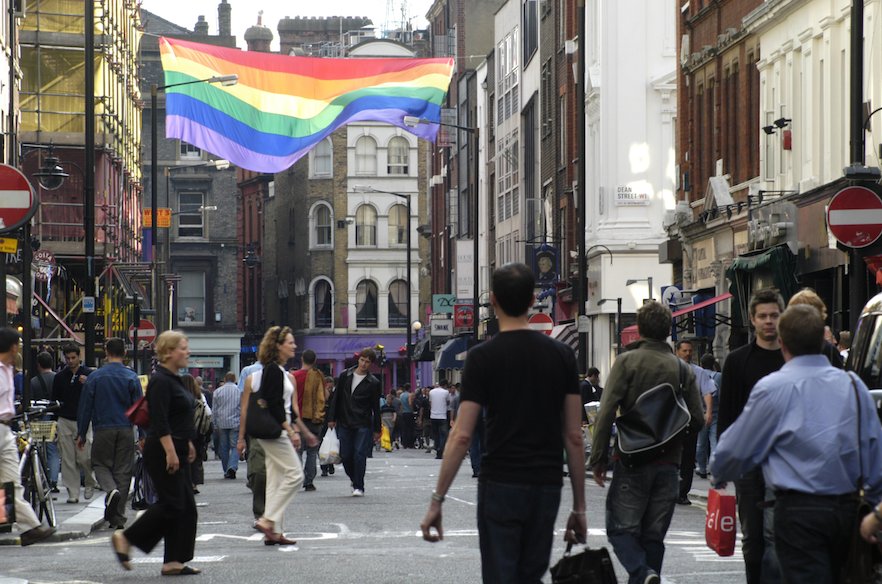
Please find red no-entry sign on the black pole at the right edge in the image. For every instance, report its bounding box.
[827,187,882,248]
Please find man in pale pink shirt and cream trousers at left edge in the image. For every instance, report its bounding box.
[0,327,55,546]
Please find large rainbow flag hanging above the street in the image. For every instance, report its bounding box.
[159,37,453,172]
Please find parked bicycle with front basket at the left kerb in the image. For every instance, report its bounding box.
[14,400,58,527]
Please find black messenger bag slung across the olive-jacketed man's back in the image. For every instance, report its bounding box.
[616,357,692,468]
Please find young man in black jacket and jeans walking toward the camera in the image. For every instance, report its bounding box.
[327,348,381,497]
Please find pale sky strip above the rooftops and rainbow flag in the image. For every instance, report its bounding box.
[141,0,432,50]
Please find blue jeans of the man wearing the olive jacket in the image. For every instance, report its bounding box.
[606,461,679,584]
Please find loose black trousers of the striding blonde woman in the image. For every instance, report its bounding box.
[124,438,196,564]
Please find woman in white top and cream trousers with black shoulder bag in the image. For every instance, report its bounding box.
[239,326,318,545]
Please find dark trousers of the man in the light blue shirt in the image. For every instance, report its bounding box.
[775,491,857,584]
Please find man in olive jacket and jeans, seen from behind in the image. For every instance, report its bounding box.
[591,301,704,584]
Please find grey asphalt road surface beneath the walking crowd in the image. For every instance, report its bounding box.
[0,450,745,584]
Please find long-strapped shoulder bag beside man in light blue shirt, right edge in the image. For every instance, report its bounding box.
[839,373,882,584]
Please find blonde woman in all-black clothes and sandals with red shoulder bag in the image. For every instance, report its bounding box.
[110,331,202,576]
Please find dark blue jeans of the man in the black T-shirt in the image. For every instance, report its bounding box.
[478,480,561,584]
